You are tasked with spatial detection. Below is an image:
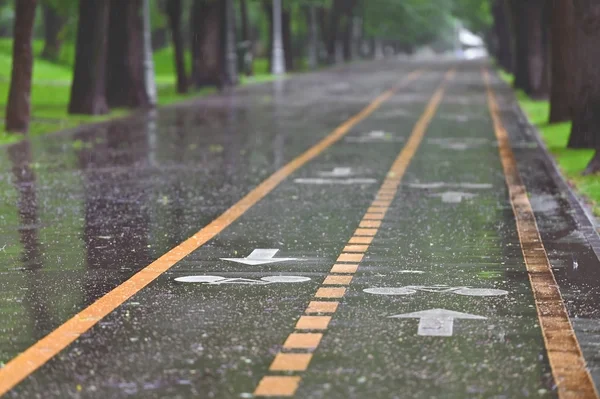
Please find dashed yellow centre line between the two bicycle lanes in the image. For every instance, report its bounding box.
[254,70,455,396]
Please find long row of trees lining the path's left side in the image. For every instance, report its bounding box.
[0,0,489,136]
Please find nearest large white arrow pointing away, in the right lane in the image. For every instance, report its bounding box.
[389,309,487,337]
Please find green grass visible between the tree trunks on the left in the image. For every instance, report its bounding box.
[0,39,273,145]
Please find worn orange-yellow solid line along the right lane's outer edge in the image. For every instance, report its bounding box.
[483,69,598,399]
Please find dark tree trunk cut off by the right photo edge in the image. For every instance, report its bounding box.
[568,0,600,173]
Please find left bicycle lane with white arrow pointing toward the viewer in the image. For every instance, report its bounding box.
[2,73,448,397]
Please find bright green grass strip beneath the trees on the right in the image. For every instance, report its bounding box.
[499,71,600,216]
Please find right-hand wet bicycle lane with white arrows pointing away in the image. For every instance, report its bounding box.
[297,66,596,398]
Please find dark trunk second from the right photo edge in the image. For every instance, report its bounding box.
[550,0,575,123]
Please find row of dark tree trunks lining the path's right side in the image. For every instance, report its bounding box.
[492,0,600,174]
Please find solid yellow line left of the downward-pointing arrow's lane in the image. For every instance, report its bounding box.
[0,70,422,396]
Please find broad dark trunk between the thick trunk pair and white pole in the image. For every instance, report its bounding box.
[192,0,226,88]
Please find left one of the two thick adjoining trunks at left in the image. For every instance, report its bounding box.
[69,0,110,115]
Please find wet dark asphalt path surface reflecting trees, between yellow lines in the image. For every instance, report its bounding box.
[0,61,600,398]
